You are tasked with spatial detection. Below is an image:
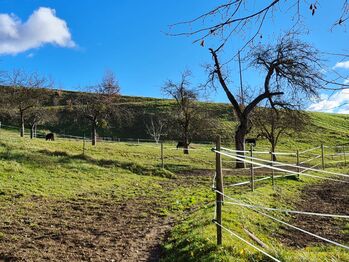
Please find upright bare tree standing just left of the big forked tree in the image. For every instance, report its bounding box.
[162,71,198,154]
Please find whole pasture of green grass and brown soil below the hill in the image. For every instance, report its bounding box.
[0,114,349,261]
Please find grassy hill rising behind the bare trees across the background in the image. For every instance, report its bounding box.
[0,87,349,146]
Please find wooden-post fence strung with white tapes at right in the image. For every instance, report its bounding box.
[212,137,349,261]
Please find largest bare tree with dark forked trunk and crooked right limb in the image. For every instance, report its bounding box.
[205,36,327,168]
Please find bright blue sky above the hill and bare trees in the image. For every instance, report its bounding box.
[0,0,349,111]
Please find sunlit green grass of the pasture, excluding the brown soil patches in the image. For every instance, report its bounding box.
[0,126,349,261]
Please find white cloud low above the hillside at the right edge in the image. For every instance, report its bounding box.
[308,89,349,114]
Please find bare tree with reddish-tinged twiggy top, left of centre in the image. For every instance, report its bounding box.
[79,71,120,145]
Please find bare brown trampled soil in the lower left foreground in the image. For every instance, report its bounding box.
[0,197,171,262]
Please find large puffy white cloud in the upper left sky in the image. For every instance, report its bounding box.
[0,7,75,54]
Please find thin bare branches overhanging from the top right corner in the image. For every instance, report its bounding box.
[169,0,349,89]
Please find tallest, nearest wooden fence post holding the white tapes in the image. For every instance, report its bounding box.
[216,136,224,245]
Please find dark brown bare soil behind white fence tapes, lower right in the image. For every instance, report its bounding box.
[276,182,349,248]
